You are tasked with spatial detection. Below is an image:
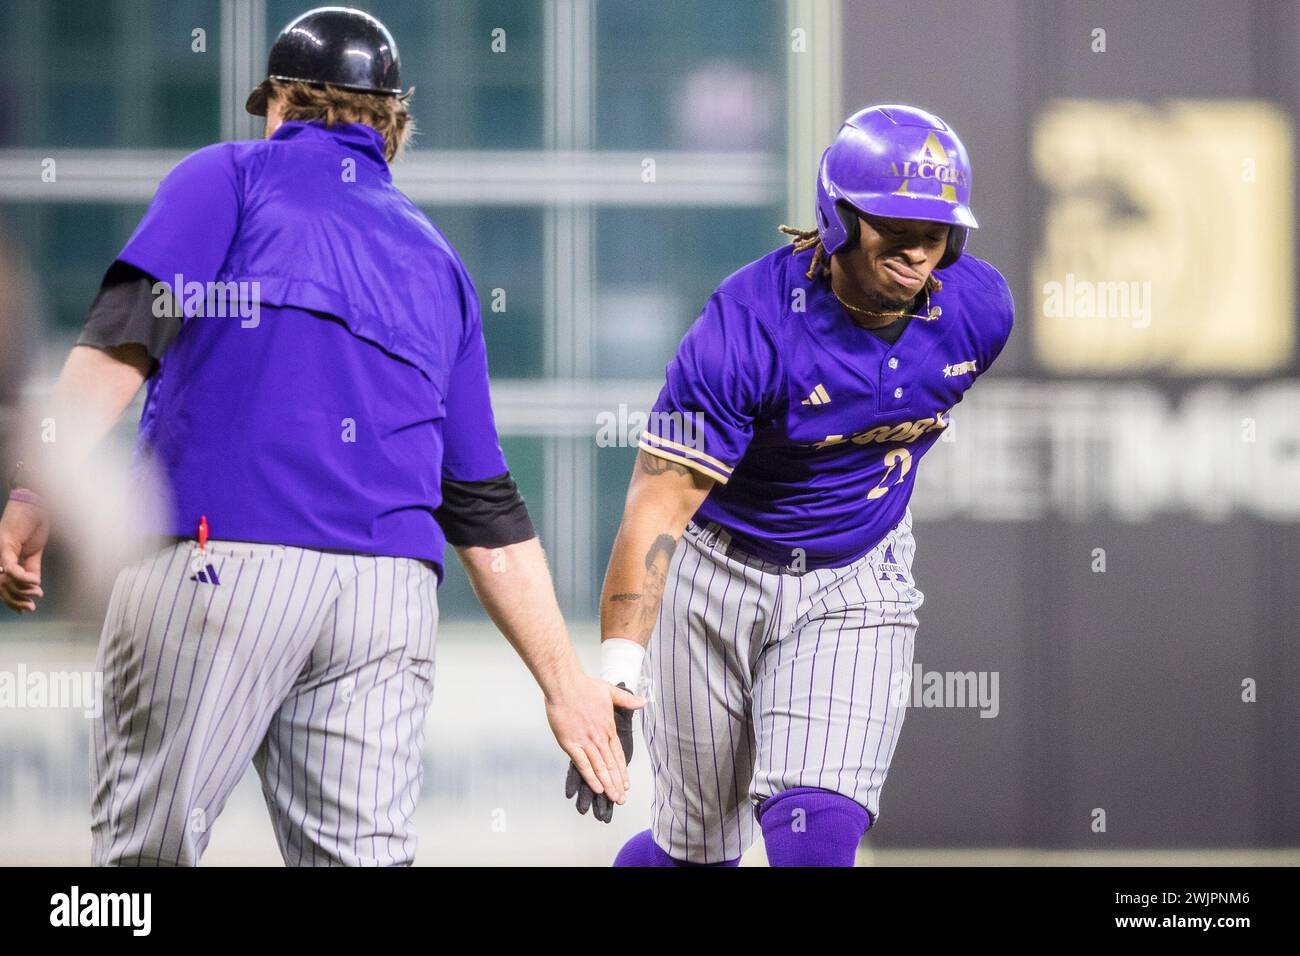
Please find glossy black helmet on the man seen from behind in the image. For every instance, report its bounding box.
[244,7,402,116]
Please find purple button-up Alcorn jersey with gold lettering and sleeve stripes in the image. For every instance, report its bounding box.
[640,246,1013,568]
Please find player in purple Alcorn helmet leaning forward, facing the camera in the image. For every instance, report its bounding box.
[576,105,1013,866]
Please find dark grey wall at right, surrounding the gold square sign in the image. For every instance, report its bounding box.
[844,0,1300,849]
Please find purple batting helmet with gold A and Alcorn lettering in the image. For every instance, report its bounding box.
[816,105,979,269]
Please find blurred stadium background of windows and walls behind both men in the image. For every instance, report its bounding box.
[0,0,1300,865]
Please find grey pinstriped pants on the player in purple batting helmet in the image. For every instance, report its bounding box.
[642,510,924,864]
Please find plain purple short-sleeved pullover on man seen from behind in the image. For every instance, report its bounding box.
[118,122,507,568]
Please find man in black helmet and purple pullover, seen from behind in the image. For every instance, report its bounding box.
[0,7,640,865]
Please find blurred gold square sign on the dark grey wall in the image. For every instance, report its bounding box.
[1032,100,1296,375]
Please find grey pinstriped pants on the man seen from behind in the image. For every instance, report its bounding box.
[91,541,438,866]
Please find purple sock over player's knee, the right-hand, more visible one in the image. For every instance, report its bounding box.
[758,787,871,866]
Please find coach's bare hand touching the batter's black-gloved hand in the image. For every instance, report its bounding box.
[546,674,645,813]
